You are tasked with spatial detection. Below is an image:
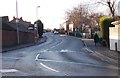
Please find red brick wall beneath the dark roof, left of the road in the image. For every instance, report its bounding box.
[2,30,34,49]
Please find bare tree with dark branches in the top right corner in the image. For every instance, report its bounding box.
[98,0,116,17]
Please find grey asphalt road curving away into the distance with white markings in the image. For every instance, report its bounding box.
[0,33,118,76]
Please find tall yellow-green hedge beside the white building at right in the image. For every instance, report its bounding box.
[100,17,114,46]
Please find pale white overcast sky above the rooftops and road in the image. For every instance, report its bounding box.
[0,0,119,29]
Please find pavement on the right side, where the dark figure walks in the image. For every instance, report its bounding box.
[81,38,120,65]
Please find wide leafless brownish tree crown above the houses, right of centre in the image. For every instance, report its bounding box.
[66,5,102,34]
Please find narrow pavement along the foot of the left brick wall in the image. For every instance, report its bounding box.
[2,36,47,52]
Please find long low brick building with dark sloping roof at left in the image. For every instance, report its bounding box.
[0,16,34,49]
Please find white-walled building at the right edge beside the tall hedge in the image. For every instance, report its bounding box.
[109,20,120,51]
